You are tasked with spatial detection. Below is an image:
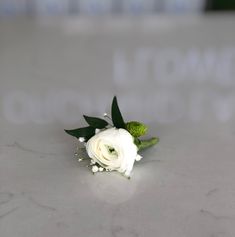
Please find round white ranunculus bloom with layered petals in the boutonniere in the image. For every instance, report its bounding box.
[86,128,139,176]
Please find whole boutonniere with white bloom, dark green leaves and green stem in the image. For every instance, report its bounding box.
[65,96,159,178]
